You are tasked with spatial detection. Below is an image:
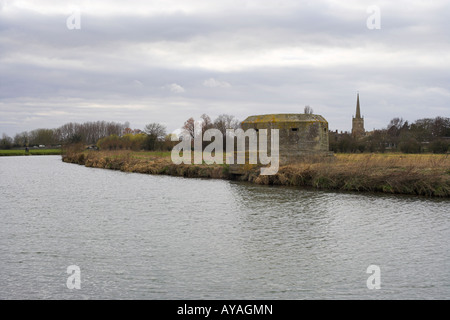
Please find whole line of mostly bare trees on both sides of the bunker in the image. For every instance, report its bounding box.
[0,114,450,153]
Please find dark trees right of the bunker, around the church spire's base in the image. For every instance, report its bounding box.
[329,117,450,153]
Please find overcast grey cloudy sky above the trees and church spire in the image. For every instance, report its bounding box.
[0,0,450,136]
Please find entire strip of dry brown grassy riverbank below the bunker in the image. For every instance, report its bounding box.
[62,151,450,197]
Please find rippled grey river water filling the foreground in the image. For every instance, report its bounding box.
[0,156,450,300]
